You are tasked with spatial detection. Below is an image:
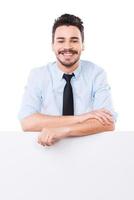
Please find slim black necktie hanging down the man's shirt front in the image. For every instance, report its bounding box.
[63,74,74,115]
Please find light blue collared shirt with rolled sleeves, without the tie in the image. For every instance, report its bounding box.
[19,60,116,120]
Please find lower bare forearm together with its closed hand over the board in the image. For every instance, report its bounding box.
[38,119,114,146]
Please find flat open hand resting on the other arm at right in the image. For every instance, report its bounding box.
[81,108,114,125]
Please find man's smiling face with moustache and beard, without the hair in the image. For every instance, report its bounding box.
[52,26,84,68]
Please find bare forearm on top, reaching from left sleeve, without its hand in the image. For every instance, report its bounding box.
[21,113,87,131]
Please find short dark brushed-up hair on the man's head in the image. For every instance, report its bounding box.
[52,14,84,42]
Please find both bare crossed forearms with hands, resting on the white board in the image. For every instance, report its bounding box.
[21,109,115,146]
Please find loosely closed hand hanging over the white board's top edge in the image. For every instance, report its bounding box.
[38,127,68,146]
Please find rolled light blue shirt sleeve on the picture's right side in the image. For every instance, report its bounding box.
[93,69,117,121]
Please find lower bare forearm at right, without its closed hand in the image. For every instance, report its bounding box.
[67,119,115,137]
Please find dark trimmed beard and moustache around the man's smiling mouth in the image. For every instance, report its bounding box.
[57,49,80,68]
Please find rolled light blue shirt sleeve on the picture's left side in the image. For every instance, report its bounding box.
[18,69,42,120]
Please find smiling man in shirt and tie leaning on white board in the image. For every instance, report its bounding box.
[19,14,116,146]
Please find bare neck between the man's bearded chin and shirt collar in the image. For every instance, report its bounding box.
[57,61,79,74]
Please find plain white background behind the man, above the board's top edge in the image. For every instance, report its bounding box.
[0,0,134,131]
